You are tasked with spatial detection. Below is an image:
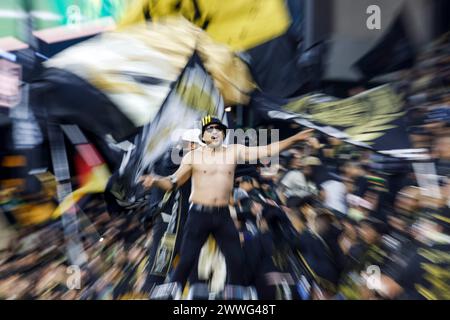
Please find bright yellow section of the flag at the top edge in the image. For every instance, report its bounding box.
[119,0,291,51]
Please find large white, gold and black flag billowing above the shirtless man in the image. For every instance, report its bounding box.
[32,18,255,141]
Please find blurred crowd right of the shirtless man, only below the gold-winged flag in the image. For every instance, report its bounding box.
[229,133,450,299]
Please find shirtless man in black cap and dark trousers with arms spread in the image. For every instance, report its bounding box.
[141,116,312,286]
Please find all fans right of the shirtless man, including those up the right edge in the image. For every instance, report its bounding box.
[225,35,450,299]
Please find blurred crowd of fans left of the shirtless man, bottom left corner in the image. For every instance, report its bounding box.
[0,196,151,300]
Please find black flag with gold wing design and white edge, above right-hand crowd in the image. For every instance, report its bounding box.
[251,85,426,159]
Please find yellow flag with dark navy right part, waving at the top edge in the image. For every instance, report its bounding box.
[119,0,325,97]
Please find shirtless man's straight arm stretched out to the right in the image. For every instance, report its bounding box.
[237,129,314,161]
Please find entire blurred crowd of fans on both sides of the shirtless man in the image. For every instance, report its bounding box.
[0,32,450,299]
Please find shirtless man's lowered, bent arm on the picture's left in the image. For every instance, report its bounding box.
[139,153,192,191]
